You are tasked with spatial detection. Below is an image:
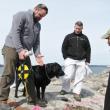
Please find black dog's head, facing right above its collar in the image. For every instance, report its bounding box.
[46,63,64,78]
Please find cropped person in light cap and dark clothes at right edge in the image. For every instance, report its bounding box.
[102,29,110,110]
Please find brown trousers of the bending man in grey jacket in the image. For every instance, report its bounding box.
[0,46,35,101]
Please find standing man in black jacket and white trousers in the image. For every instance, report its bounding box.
[60,21,91,101]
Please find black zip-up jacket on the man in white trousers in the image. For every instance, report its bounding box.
[62,32,91,63]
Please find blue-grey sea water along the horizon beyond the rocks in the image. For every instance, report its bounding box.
[0,65,108,76]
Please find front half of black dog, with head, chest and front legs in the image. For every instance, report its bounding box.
[32,63,64,102]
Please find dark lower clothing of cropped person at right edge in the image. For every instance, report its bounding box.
[104,73,110,110]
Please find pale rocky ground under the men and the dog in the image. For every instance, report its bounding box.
[1,72,109,110]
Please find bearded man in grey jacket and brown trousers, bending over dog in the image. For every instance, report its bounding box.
[0,4,48,106]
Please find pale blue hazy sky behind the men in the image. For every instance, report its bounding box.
[0,0,110,65]
